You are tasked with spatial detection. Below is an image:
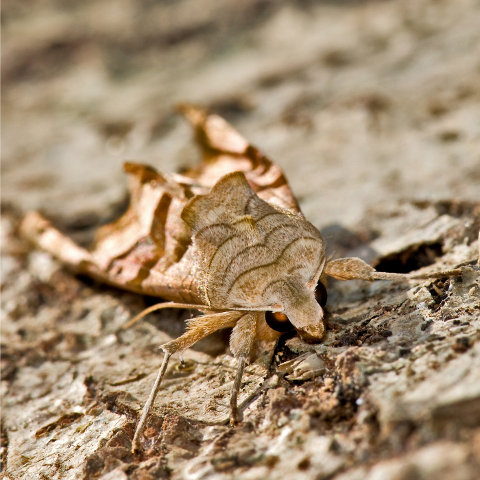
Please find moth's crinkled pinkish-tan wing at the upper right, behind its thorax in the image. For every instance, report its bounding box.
[179,105,300,213]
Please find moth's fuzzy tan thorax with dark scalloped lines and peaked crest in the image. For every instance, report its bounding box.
[182,172,325,309]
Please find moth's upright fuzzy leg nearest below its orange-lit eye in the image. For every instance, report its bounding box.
[230,312,263,426]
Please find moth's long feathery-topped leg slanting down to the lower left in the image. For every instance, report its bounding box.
[132,312,242,453]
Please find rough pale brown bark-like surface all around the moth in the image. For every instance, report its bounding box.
[1,0,480,480]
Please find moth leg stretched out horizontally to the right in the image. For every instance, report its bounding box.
[324,257,462,282]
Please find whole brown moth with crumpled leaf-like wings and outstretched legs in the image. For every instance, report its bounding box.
[21,105,459,451]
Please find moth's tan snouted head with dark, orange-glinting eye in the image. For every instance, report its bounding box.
[266,277,325,343]
